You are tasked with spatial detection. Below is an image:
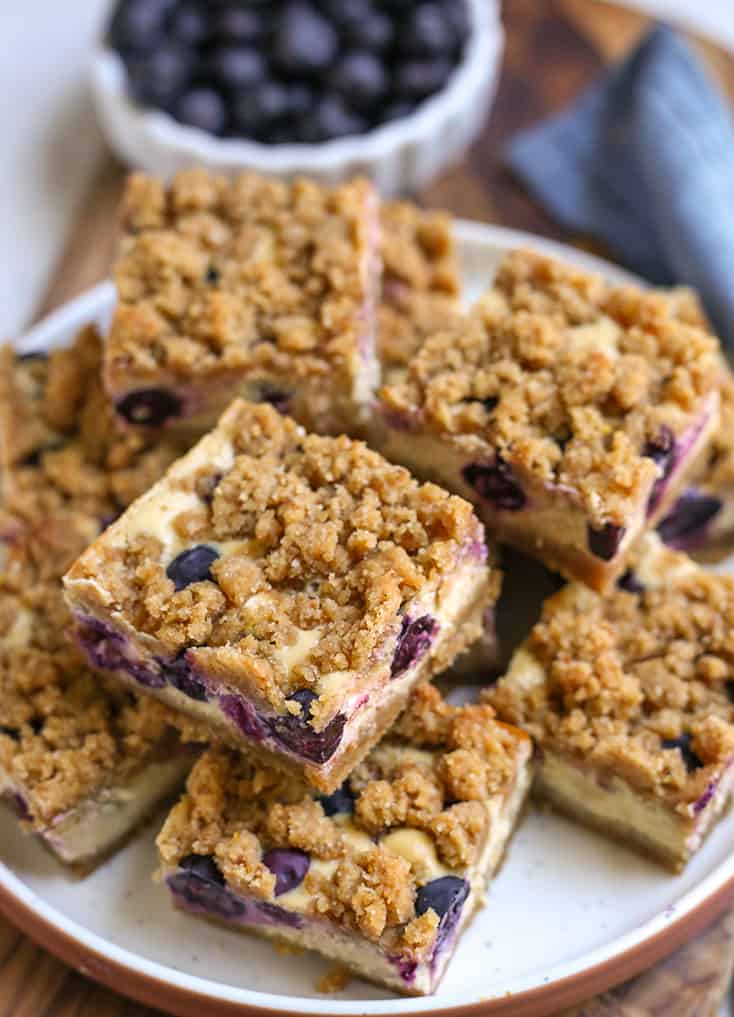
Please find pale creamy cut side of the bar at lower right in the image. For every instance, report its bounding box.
[536,750,734,866]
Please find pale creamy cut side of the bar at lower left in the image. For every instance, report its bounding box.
[0,751,194,864]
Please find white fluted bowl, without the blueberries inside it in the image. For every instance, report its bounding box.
[91,0,504,196]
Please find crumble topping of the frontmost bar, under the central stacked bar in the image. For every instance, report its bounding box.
[157,685,529,957]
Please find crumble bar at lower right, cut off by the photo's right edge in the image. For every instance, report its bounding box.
[489,534,734,869]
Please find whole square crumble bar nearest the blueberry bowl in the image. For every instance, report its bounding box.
[105,170,380,434]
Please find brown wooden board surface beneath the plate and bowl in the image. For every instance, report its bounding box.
[0,0,734,1017]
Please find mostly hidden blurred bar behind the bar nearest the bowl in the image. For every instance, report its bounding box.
[377,201,461,383]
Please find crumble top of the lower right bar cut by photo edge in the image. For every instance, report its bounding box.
[487,536,734,812]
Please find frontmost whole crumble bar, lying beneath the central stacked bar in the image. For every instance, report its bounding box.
[158,685,531,996]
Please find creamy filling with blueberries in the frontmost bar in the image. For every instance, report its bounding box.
[165,746,532,995]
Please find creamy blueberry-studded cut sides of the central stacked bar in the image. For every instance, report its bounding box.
[75,553,487,779]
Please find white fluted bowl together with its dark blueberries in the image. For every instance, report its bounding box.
[91,0,503,194]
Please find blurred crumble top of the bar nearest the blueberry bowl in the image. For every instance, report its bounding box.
[106,170,379,391]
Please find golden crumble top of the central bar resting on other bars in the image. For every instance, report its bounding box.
[67,394,499,715]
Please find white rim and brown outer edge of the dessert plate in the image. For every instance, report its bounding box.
[0,220,734,1017]
